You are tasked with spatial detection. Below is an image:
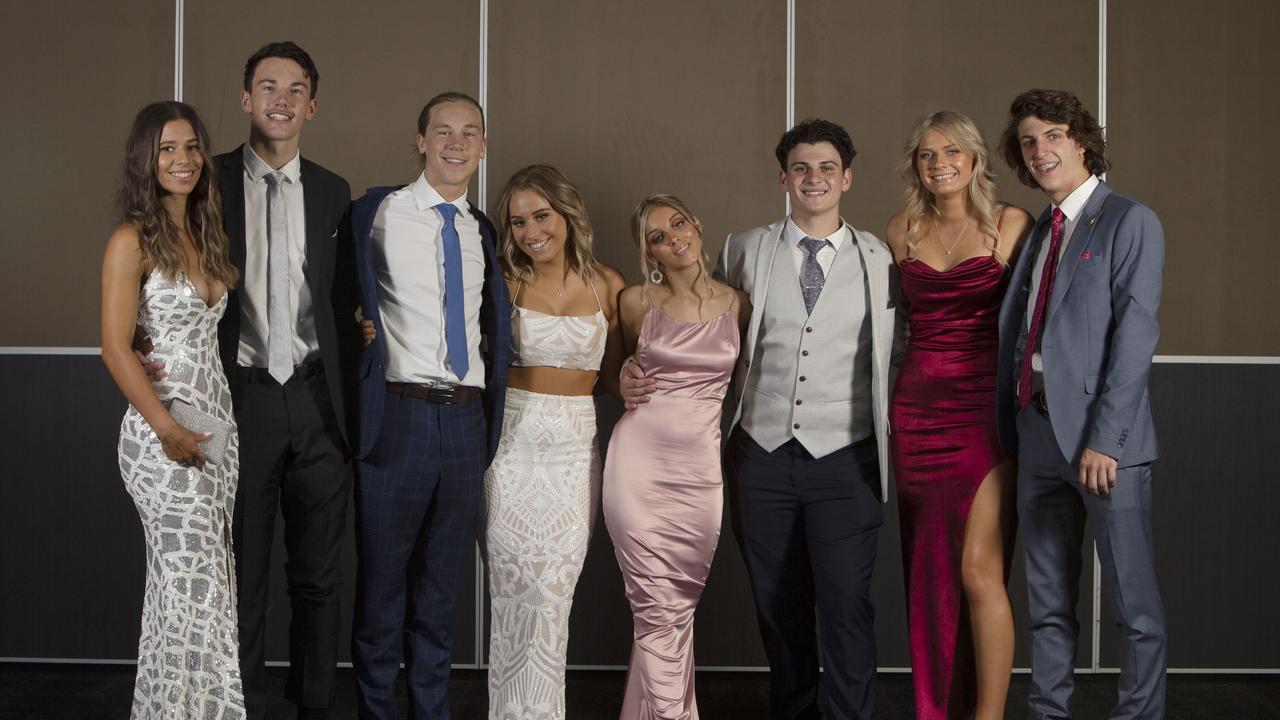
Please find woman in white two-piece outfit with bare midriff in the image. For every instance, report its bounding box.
[484,165,626,720]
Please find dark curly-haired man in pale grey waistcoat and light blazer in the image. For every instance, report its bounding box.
[716,120,901,720]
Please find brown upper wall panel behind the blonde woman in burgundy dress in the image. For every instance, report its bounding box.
[796,0,1098,252]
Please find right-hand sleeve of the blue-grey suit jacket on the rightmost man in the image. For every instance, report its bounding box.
[1087,205,1165,457]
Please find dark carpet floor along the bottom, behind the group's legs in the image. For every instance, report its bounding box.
[0,664,1280,720]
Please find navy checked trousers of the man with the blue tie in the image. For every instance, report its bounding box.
[352,395,485,720]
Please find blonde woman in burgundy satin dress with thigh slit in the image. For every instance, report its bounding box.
[887,110,1032,720]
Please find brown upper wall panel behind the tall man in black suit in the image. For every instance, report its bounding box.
[186,0,480,197]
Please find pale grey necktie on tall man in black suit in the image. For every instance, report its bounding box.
[262,172,293,386]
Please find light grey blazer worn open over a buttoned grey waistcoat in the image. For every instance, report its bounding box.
[716,219,902,500]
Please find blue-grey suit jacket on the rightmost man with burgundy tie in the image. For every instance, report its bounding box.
[998,183,1165,468]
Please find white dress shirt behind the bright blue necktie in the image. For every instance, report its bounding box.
[374,176,485,388]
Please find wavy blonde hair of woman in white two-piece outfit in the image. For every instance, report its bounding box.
[497,165,599,284]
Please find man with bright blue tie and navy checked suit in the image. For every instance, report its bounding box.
[351,92,511,720]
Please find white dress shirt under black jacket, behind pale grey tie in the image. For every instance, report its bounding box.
[236,142,320,368]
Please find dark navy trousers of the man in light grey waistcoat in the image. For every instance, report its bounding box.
[724,428,884,720]
